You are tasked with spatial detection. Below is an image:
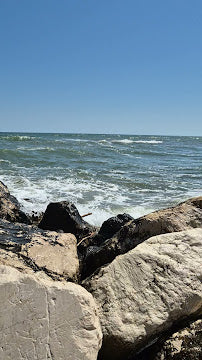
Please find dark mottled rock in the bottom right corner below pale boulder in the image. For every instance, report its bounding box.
[134,319,202,360]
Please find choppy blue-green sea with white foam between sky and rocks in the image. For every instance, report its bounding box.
[0,132,202,225]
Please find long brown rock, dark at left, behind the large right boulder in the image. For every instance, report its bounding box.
[82,197,202,279]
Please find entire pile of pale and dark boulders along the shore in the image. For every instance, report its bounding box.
[0,182,202,360]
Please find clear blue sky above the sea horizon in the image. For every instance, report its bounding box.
[0,0,202,135]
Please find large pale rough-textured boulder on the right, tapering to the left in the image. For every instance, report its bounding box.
[83,229,202,360]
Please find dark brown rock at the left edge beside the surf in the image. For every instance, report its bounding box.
[0,181,30,224]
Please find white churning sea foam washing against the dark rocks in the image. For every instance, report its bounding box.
[1,176,129,225]
